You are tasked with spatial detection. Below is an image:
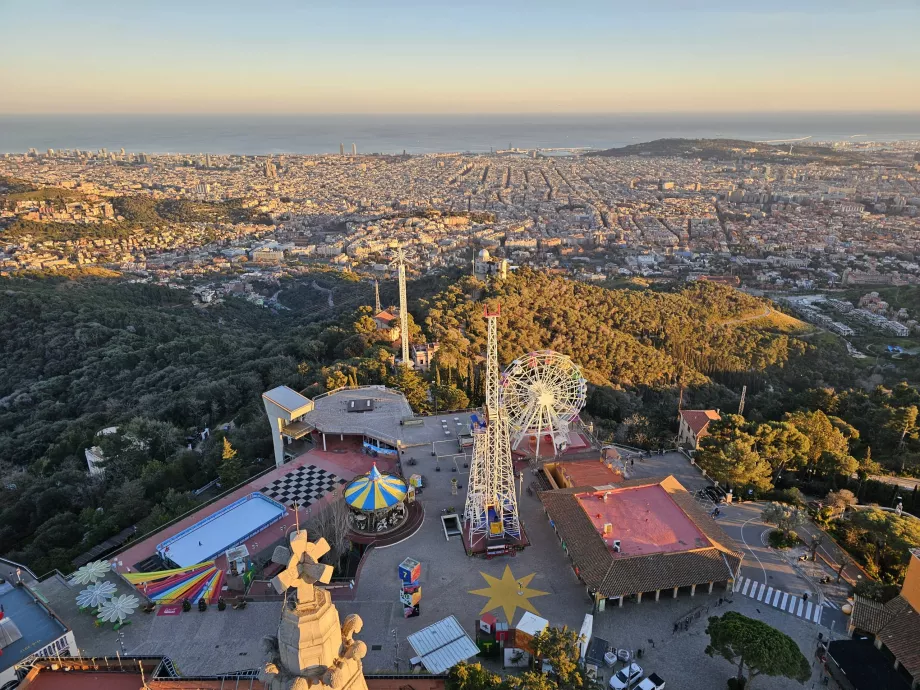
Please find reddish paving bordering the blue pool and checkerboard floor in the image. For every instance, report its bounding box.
[117,439,388,572]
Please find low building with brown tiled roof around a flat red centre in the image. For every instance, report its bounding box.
[540,476,743,606]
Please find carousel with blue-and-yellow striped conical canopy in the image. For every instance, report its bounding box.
[345,464,409,533]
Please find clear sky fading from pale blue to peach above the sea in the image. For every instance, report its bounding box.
[0,0,920,113]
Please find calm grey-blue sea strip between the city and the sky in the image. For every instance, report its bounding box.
[0,113,920,155]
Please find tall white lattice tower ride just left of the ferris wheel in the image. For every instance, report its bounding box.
[464,308,521,544]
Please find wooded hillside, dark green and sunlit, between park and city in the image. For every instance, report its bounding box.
[0,268,920,573]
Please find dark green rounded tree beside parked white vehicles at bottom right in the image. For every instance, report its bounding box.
[706,611,811,687]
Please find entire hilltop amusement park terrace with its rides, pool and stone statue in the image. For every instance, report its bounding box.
[0,336,832,690]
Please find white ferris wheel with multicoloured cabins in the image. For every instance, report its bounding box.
[501,350,587,457]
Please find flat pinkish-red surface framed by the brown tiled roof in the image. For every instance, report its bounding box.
[578,485,711,556]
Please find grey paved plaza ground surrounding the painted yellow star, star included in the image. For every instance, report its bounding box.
[338,447,839,690]
